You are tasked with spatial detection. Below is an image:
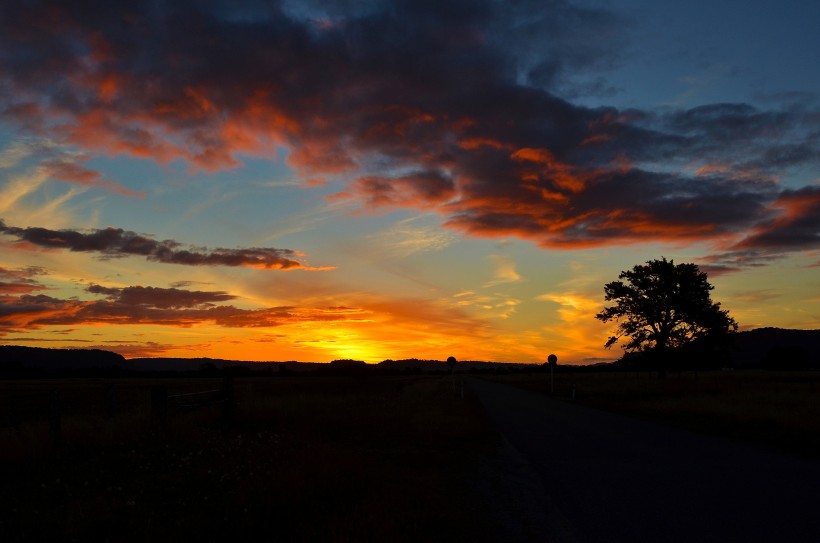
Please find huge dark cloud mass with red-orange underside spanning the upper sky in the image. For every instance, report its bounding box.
[0,0,820,265]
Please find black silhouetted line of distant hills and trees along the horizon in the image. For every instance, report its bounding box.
[0,328,820,378]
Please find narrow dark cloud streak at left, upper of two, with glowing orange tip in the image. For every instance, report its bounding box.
[0,220,326,270]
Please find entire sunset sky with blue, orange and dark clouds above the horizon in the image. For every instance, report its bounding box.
[0,0,820,363]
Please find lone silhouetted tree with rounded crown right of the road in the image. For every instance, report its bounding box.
[595,258,737,374]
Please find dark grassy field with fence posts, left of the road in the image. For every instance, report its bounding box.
[0,376,497,542]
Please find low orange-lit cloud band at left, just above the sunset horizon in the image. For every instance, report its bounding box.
[0,285,365,334]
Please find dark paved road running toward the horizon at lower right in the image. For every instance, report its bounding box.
[470,379,820,543]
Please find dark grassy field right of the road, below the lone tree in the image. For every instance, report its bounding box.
[484,370,820,458]
